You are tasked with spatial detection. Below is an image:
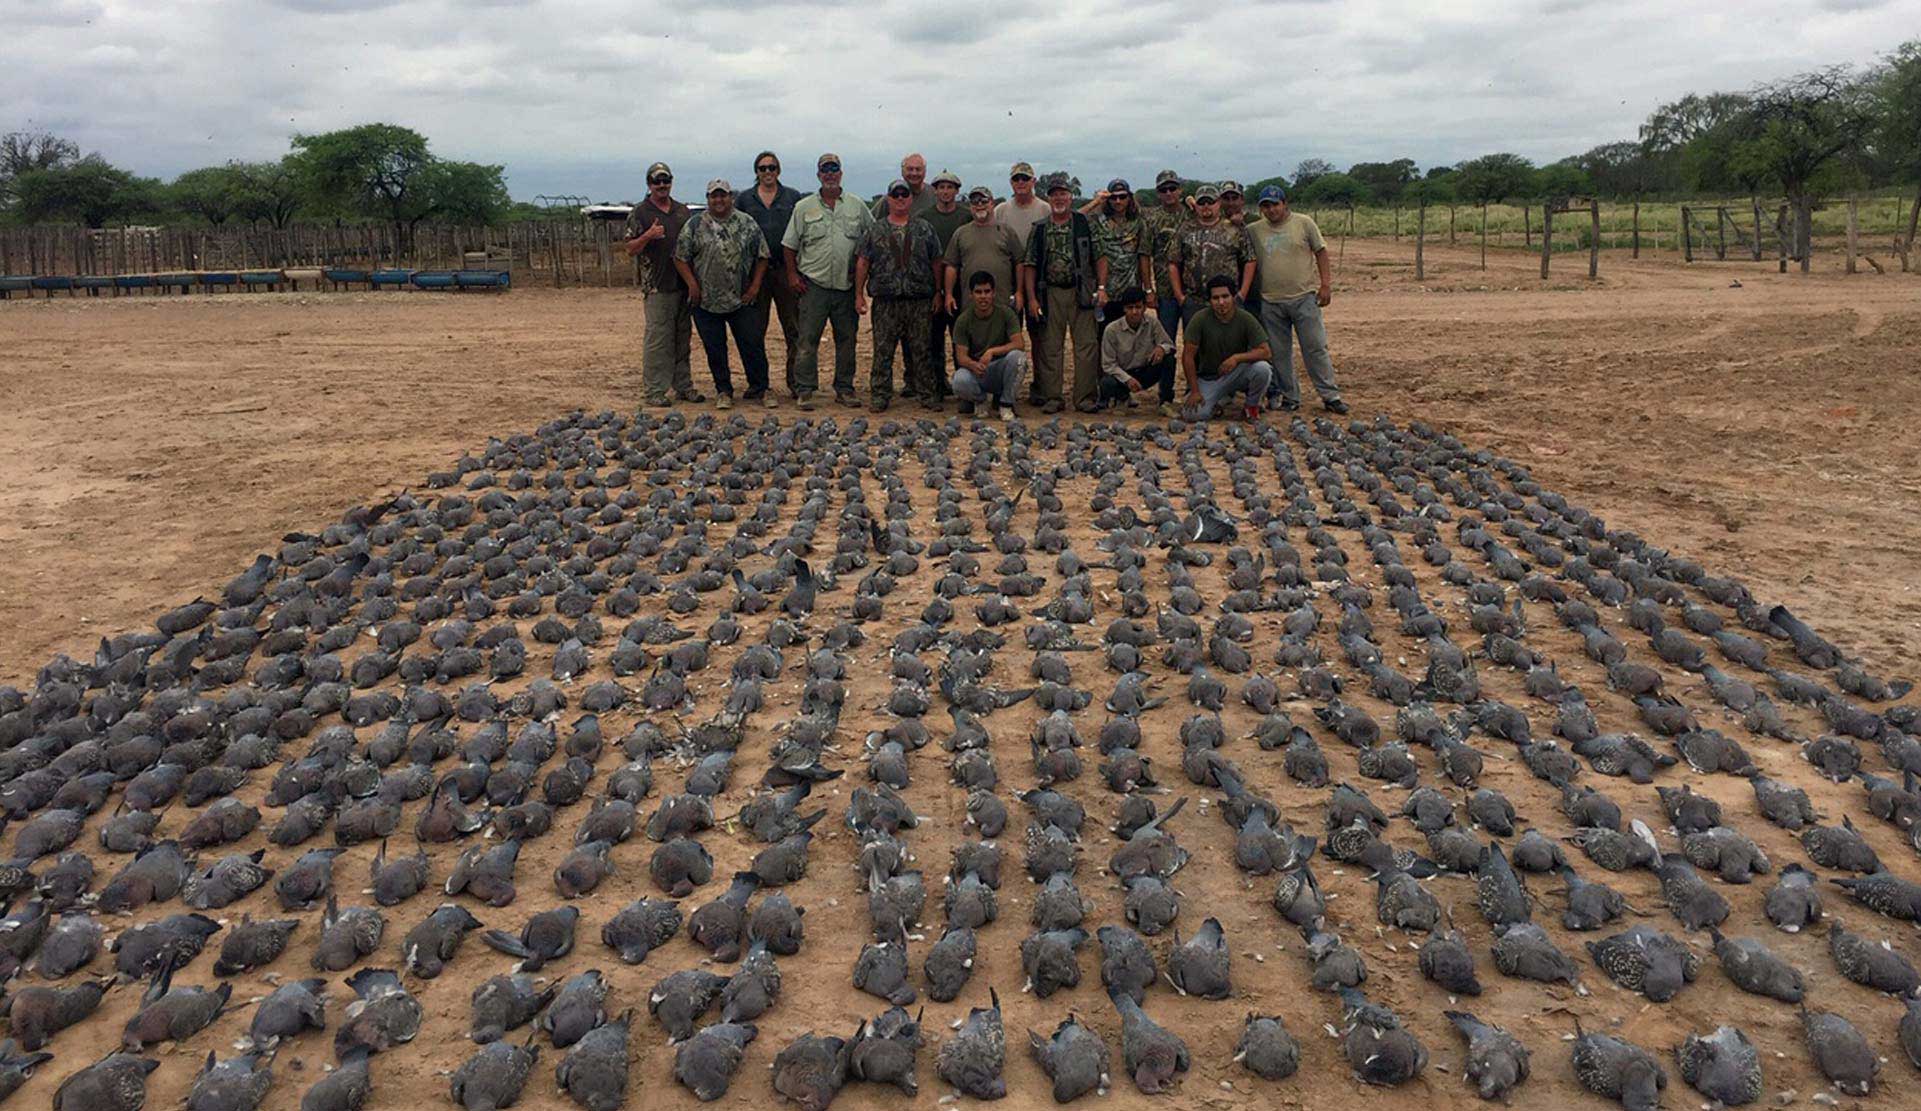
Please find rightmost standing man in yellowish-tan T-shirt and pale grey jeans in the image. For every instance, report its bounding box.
[1247,185,1347,413]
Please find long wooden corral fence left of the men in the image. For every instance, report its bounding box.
[0,217,634,286]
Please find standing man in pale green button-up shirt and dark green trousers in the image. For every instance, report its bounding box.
[780,154,874,409]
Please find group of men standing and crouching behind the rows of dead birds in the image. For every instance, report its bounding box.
[624,150,1347,419]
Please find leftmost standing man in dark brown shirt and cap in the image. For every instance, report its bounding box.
[620,161,707,407]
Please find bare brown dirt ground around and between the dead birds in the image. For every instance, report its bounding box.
[0,240,1921,1109]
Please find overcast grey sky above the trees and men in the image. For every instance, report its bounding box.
[0,0,1921,200]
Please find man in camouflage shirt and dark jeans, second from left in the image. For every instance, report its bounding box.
[674,177,774,409]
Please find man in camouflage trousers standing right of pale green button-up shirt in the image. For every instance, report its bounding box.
[853,177,941,413]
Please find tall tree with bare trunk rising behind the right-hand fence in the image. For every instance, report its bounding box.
[1733,65,1875,273]
